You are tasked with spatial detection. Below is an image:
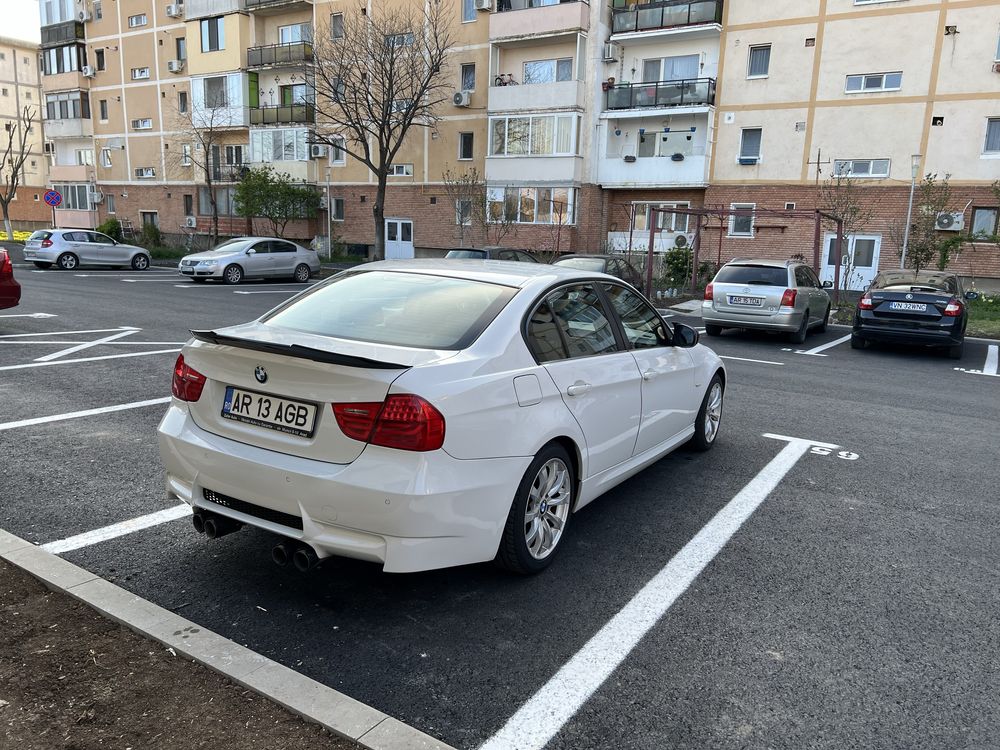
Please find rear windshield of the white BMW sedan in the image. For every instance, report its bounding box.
[262,271,517,350]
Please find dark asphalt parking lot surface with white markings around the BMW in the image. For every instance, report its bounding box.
[0,267,1000,750]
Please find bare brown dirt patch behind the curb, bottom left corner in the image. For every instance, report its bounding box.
[0,561,358,750]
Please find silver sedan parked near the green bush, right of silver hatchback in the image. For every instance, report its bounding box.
[177,237,320,284]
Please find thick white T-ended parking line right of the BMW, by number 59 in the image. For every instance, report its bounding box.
[480,435,839,750]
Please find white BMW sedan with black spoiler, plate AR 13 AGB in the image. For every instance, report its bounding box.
[159,260,726,573]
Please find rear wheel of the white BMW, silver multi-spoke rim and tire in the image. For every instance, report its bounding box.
[494,443,576,575]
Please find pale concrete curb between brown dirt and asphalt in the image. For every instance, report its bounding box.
[0,529,454,750]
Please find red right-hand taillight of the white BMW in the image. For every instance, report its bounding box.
[333,393,444,451]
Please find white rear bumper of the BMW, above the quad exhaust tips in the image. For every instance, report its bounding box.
[158,401,531,573]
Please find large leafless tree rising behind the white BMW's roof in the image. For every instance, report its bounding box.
[313,0,453,258]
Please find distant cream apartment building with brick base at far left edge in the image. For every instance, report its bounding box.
[0,37,50,226]
